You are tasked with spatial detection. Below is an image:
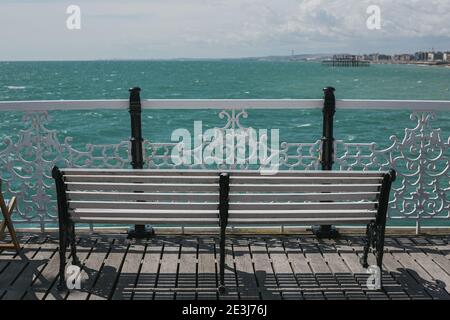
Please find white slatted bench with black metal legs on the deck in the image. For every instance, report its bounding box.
[53,167,395,293]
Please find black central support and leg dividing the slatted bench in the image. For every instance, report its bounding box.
[218,173,230,294]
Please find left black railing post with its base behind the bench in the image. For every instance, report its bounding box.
[128,87,154,239]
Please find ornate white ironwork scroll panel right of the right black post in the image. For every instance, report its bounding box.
[335,112,450,228]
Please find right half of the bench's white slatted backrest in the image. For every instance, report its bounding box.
[228,171,385,225]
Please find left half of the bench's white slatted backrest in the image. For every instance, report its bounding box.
[61,169,219,226]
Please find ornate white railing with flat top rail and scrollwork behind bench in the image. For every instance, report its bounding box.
[0,99,450,231]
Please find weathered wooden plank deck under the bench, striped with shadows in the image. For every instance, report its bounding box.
[0,234,450,300]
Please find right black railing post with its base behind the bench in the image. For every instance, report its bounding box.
[312,87,338,238]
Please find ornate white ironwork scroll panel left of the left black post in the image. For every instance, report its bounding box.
[0,112,130,230]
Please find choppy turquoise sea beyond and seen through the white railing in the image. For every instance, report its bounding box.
[0,60,450,228]
